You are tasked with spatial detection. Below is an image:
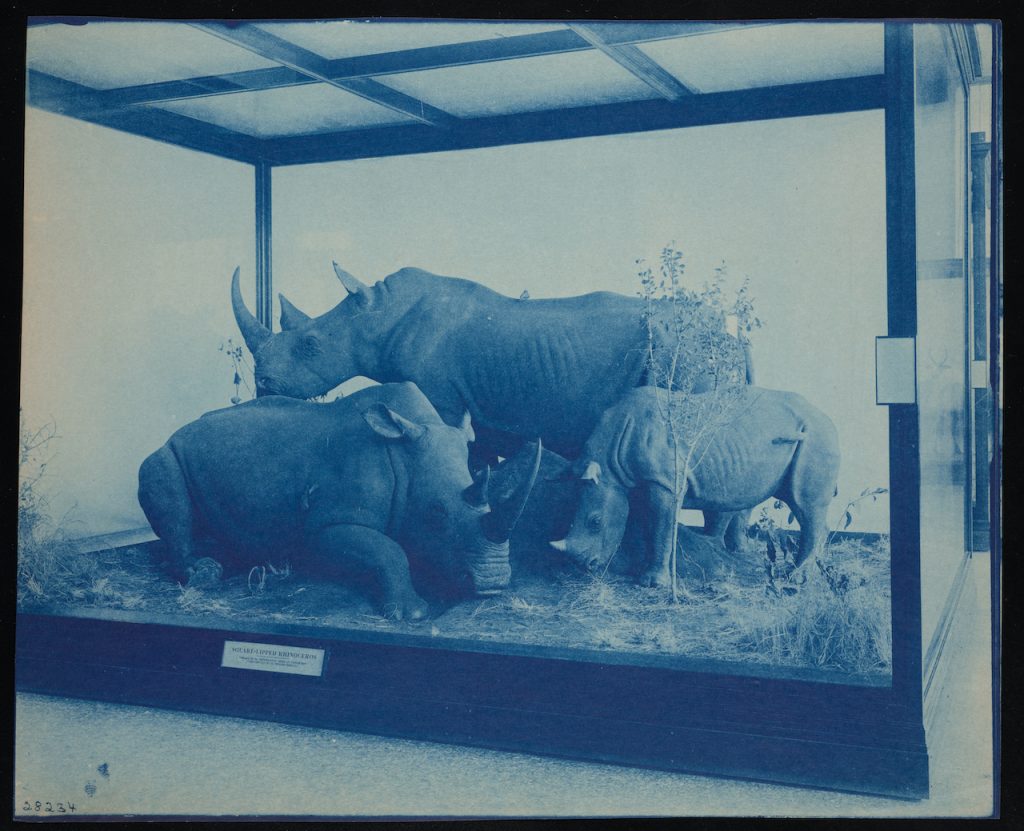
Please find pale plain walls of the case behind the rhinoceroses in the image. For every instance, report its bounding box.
[22,103,888,533]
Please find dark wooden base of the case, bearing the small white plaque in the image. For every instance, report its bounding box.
[16,612,928,798]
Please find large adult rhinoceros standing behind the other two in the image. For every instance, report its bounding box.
[231,265,752,458]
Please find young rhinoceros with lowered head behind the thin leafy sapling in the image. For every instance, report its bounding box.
[552,386,840,585]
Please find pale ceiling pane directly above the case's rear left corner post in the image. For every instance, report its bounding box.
[151,84,415,138]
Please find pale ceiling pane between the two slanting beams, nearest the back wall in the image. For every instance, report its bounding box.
[380,51,656,118]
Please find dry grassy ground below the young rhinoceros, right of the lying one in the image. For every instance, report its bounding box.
[432,538,892,674]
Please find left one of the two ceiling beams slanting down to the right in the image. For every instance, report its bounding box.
[191,23,458,127]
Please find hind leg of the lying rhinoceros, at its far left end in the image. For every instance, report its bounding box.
[138,447,223,585]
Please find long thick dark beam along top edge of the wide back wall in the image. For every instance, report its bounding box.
[263,75,885,165]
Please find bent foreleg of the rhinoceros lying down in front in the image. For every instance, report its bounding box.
[302,525,430,620]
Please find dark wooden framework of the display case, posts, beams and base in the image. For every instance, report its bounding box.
[15,23,996,798]
